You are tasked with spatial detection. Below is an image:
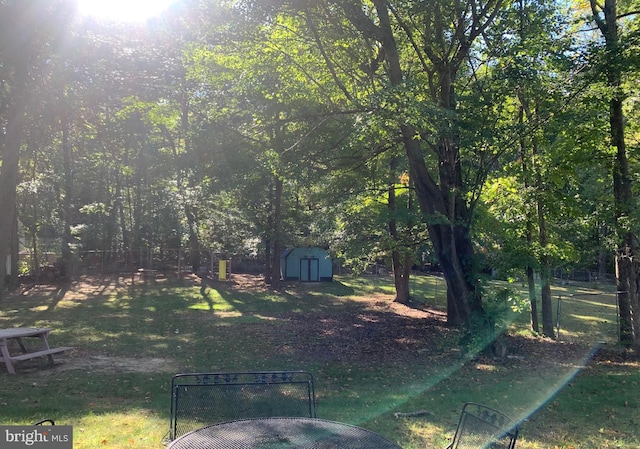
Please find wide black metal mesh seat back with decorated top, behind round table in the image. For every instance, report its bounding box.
[169,371,317,441]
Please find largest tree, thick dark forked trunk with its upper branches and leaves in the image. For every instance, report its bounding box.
[296,0,502,325]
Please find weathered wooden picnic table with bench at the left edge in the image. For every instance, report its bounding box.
[0,327,73,374]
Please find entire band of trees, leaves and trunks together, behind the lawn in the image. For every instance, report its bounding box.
[0,0,640,345]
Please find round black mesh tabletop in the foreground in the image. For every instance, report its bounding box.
[168,418,402,449]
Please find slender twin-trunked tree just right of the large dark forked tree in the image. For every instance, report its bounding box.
[503,0,575,337]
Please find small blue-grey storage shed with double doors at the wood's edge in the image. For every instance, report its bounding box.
[280,246,333,282]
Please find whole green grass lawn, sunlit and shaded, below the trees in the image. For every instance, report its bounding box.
[0,276,640,449]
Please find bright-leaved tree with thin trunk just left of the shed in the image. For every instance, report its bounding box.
[194,8,356,285]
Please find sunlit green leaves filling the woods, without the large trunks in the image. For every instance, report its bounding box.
[0,0,640,328]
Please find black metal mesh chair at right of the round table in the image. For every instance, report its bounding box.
[446,402,518,449]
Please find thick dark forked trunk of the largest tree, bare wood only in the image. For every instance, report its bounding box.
[374,0,484,326]
